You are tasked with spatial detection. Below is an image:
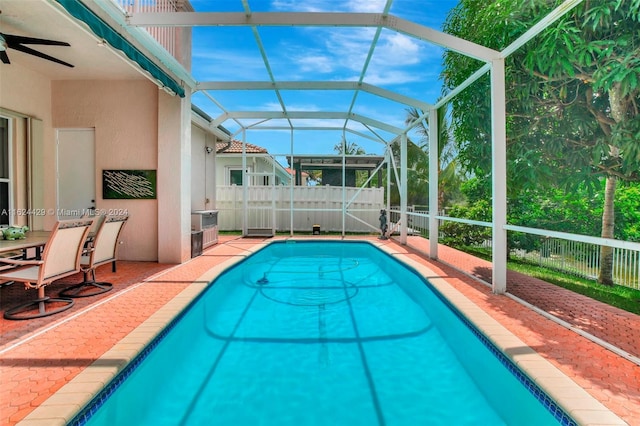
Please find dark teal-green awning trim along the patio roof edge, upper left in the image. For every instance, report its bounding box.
[56,0,184,98]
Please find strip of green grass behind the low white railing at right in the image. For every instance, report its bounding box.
[462,243,640,315]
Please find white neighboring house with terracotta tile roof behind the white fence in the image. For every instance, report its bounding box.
[215,140,291,186]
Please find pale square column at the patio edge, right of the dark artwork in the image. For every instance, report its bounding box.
[157,89,191,263]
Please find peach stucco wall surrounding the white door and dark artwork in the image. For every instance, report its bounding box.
[47,80,158,261]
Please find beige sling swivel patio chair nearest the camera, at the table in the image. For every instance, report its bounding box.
[0,219,93,320]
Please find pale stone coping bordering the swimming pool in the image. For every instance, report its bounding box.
[18,237,627,426]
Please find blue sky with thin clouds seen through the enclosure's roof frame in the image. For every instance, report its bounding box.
[191,0,457,155]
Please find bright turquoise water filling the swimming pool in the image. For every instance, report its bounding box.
[73,241,574,426]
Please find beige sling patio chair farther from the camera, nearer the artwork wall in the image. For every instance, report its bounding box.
[59,216,129,298]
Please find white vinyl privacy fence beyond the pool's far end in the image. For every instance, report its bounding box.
[216,185,385,233]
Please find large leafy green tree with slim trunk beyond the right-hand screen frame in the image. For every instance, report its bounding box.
[443,0,640,285]
